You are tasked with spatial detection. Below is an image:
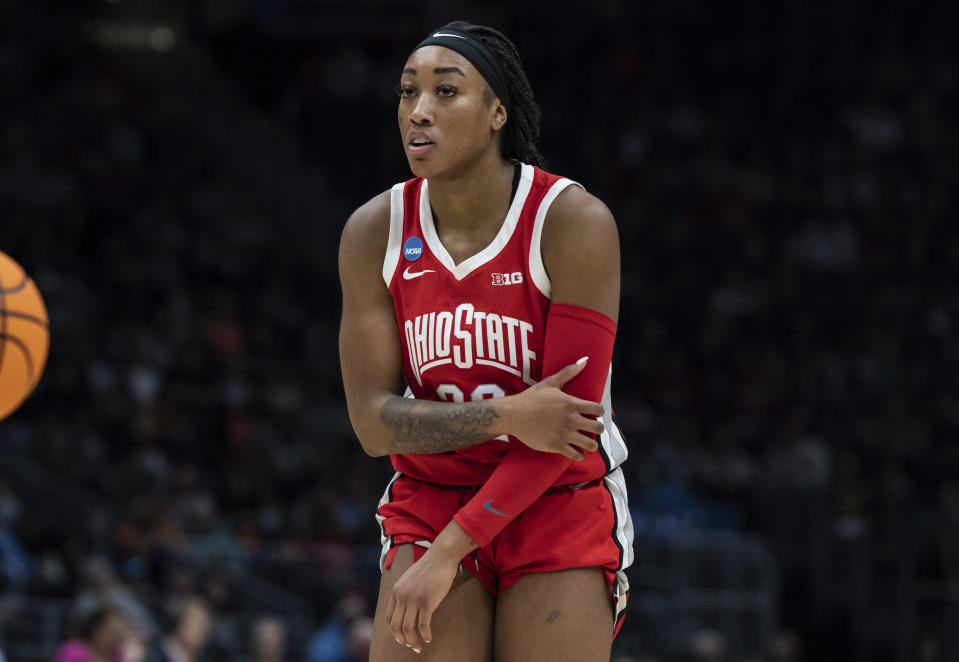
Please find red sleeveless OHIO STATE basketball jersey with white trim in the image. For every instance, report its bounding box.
[383,164,626,485]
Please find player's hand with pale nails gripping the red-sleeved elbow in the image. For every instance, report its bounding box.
[510,359,604,461]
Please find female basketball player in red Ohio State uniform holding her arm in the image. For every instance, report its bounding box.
[340,22,632,662]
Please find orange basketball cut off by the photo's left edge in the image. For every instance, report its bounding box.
[0,252,50,420]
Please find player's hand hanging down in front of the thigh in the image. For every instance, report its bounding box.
[386,550,459,653]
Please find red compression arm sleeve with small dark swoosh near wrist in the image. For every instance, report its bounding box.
[453,303,616,547]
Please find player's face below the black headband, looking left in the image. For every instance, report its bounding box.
[397,46,506,177]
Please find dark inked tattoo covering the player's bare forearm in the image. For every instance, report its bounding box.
[380,398,499,453]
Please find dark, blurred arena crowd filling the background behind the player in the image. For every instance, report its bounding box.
[0,0,959,662]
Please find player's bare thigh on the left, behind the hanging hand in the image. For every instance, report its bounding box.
[370,545,493,662]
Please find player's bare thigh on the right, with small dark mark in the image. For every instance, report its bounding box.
[494,567,613,662]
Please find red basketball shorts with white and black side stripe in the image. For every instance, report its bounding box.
[376,468,633,636]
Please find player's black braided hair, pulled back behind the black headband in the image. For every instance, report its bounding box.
[440,21,546,168]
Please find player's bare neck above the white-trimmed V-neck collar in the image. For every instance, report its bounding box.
[429,151,514,234]
